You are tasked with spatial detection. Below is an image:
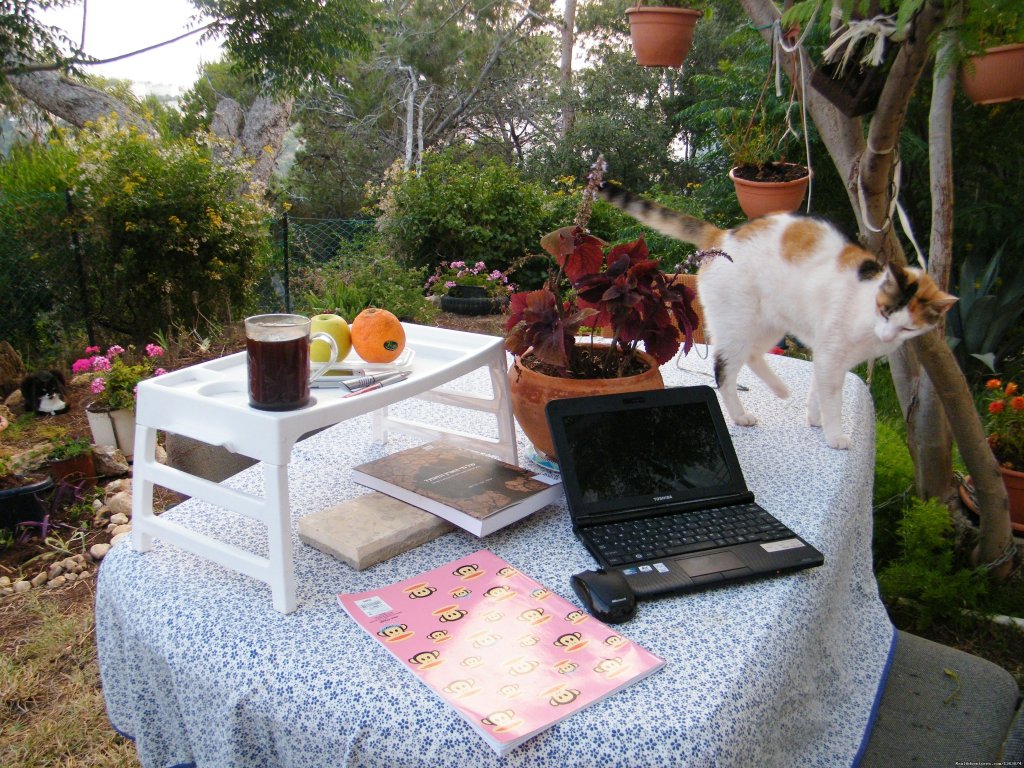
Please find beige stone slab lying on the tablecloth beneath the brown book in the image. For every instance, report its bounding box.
[299,492,455,570]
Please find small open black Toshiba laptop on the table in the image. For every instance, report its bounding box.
[547,386,824,597]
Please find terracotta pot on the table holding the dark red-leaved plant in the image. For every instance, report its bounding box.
[508,352,665,459]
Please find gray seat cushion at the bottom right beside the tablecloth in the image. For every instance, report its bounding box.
[860,632,1020,768]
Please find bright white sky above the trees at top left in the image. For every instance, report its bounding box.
[41,0,220,95]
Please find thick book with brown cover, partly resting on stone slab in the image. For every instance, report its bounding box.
[352,441,562,536]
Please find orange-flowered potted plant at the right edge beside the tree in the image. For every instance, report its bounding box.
[984,379,1024,532]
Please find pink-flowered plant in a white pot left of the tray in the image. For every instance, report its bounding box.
[72,344,166,461]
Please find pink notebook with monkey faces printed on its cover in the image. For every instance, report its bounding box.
[338,550,665,755]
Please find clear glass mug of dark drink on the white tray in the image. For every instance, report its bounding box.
[246,314,338,411]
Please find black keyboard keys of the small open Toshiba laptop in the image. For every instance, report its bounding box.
[586,504,794,565]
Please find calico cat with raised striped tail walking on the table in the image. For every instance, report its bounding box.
[600,184,956,449]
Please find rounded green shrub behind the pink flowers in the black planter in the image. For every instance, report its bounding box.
[379,153,547,271]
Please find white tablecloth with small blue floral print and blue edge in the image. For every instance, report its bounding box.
[96,347,894,768]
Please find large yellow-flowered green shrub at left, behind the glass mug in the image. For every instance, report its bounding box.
[67,121,269,342]
